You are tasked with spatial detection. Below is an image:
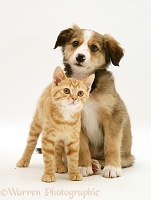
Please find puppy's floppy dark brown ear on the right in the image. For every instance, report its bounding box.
[104,34,124,66]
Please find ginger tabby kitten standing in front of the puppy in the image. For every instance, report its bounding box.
[17,67,95,182]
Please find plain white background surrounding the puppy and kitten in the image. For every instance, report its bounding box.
[0,0,151,200]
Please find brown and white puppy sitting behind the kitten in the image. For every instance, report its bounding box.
[54,25,134,178]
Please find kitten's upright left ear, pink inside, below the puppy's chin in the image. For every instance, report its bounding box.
[53,67,67,86]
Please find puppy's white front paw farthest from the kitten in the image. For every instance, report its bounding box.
[102,166,122,178]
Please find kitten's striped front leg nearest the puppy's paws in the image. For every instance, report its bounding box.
[66,140,82,181]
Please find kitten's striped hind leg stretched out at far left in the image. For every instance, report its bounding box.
[16,118,42,167]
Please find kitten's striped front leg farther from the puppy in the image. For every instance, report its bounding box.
[41,130,56,182]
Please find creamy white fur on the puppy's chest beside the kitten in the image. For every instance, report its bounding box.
[82,96,103,148]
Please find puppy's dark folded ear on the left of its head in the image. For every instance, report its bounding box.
[54,28,74,49]
